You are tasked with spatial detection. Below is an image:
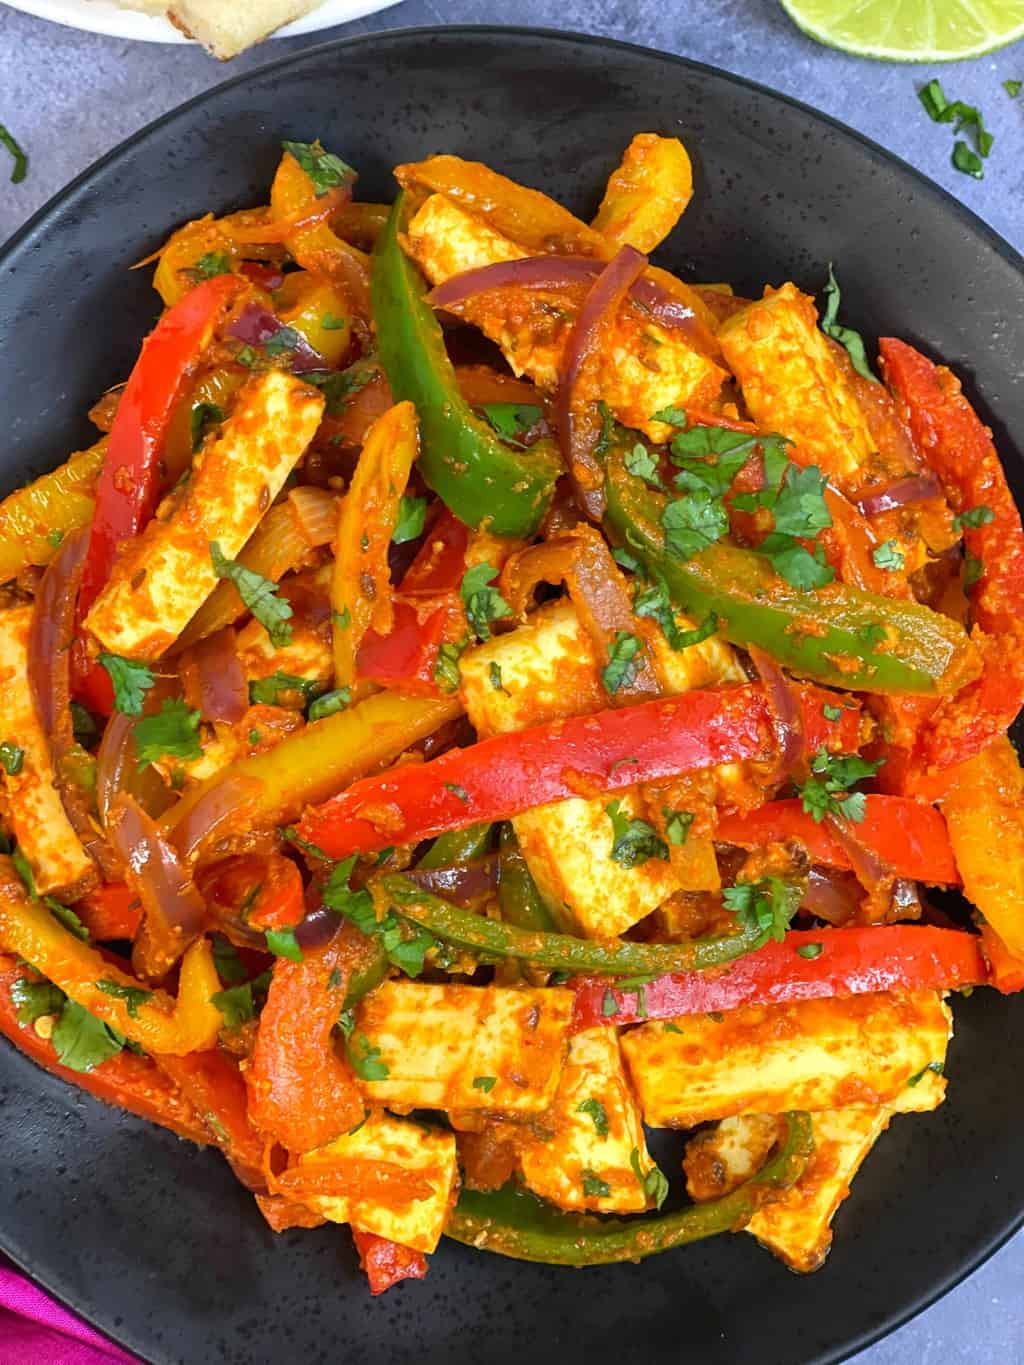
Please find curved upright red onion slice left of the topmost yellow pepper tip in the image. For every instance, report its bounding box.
[554,246,647,520]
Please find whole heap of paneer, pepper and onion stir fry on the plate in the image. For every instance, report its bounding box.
[0,132,1024,1293]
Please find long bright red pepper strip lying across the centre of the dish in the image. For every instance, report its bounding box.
[299,684,860,857]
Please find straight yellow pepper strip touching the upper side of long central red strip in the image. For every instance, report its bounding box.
[164,692,461,857]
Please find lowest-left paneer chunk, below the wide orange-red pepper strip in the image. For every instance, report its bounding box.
[294,1111,457,1252]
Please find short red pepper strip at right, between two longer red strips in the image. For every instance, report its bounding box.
[714,796,960,886]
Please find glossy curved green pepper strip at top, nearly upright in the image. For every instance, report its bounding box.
[371,194,563,538]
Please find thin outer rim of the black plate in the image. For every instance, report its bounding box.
[0,24,1024,1365]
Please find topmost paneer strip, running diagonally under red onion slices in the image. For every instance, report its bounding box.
[407,194,725,440]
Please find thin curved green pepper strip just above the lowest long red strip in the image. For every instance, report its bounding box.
[367,874,767,976]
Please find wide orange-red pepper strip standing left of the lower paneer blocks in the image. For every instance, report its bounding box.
[246,925,369,1152]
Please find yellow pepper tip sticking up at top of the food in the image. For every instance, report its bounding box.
[591,132,694,253]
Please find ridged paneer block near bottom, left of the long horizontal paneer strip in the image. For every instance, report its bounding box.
[348,981,572,1114]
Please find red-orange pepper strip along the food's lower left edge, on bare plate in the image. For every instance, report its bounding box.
[0,957,210,1145]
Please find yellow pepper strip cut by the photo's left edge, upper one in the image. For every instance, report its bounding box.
[0,437,108,583]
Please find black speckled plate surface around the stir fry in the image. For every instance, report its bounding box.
[0,21,1024,1365]
